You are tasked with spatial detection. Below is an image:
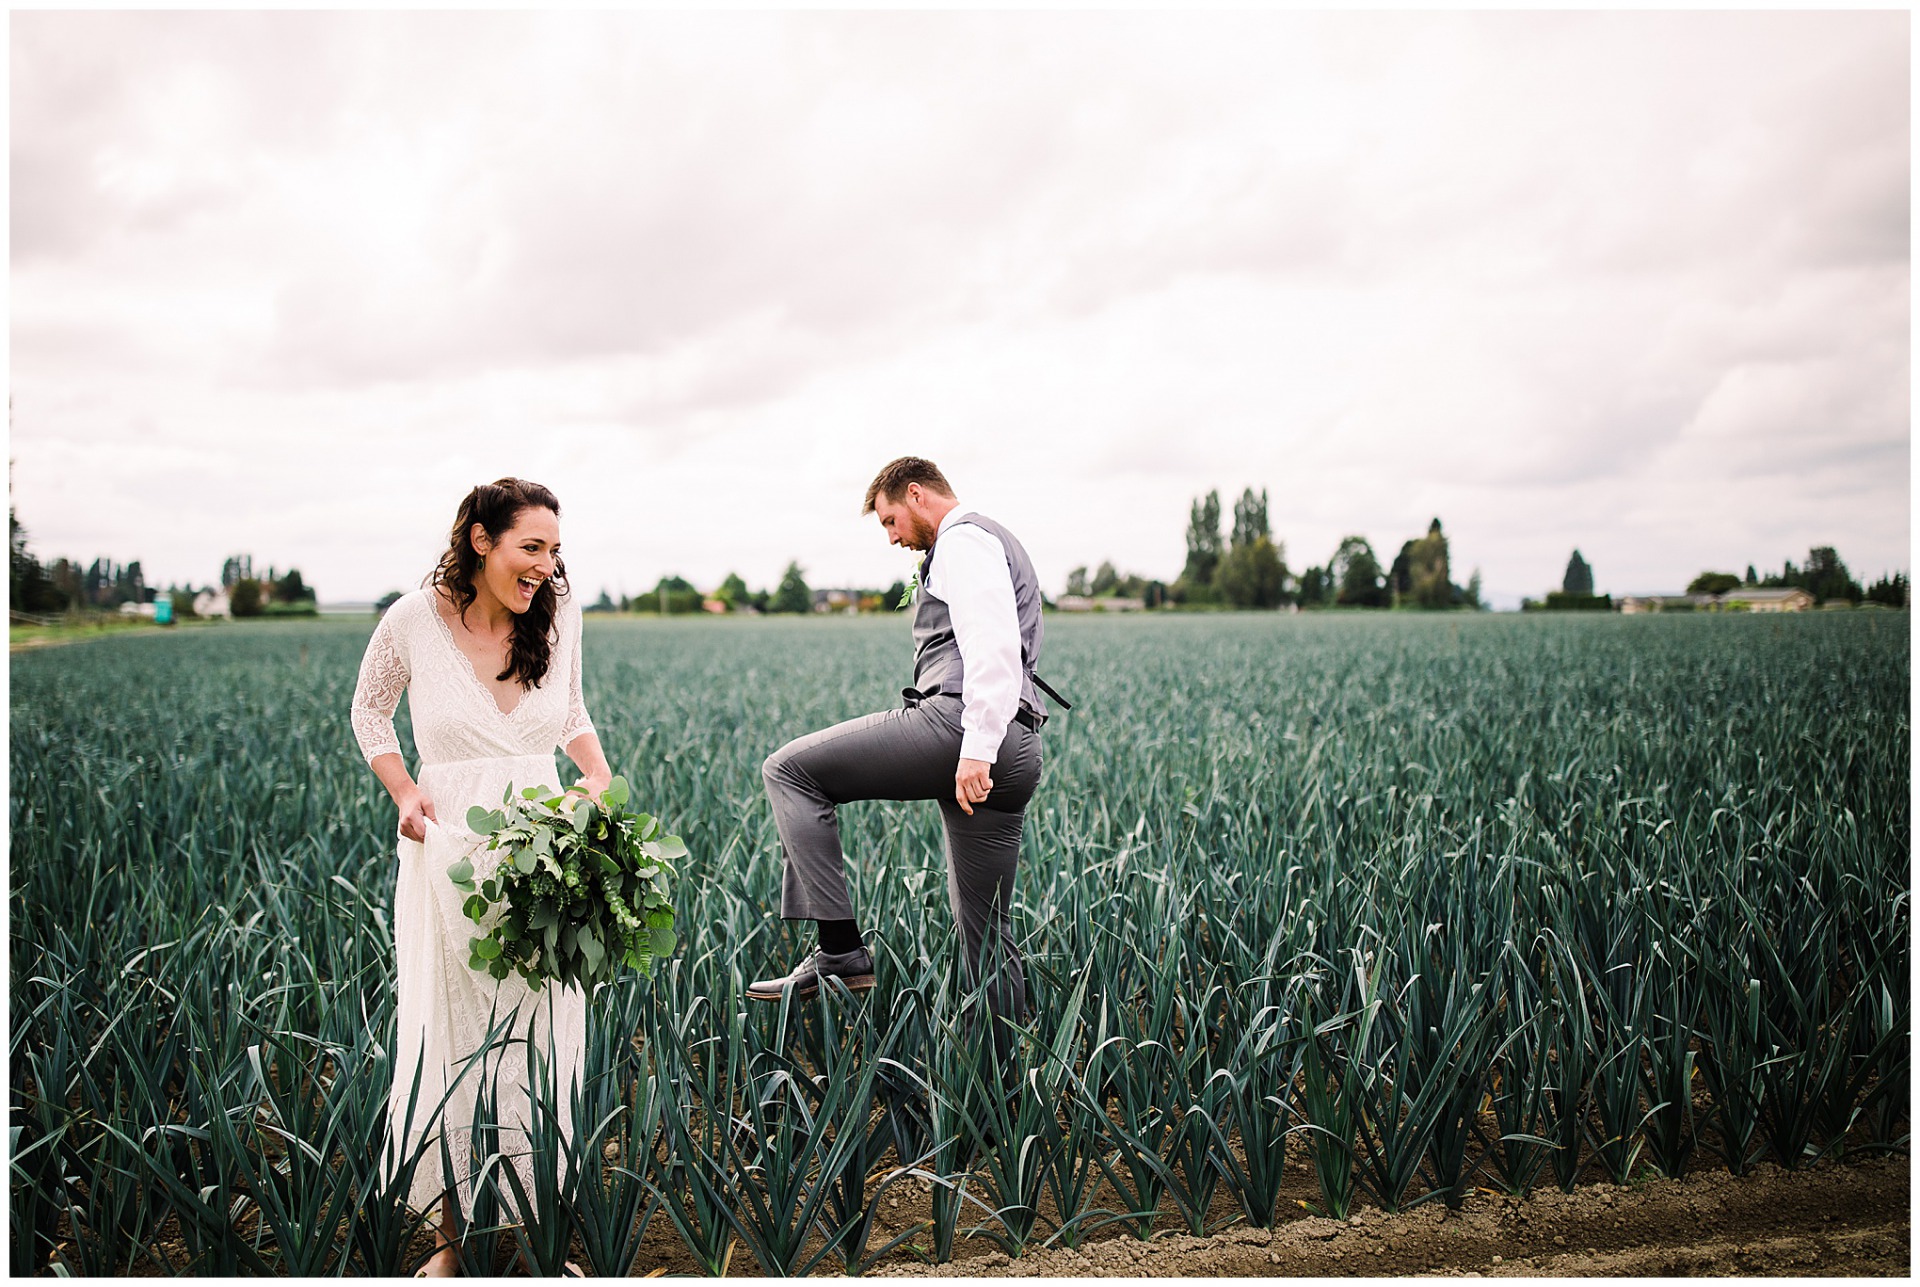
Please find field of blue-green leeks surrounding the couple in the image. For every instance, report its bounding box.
[10,613,1912,1275]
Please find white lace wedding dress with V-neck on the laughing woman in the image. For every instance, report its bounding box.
[353,588,593,1216]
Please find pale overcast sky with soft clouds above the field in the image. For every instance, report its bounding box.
[10,12,1910,603]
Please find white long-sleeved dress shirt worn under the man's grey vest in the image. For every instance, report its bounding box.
[922,505,1023,765]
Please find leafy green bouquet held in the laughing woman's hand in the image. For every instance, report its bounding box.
[447,778,687,991]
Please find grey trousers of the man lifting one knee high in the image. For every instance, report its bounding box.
[760,693,1041,1020]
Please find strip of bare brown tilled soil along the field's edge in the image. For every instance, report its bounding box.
[872,1158,1912,1277]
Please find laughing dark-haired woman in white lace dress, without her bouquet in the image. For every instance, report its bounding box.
[353,478,612,1277]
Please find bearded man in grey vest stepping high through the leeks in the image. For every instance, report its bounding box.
[747,455,1066,1045]
